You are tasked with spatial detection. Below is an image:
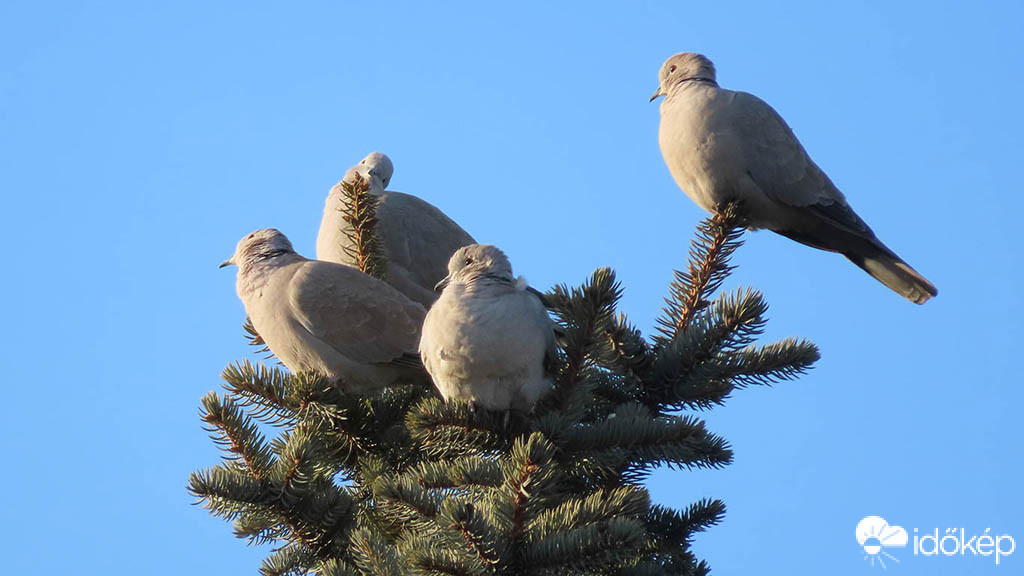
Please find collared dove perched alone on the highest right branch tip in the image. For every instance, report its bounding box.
[650,52,938,304]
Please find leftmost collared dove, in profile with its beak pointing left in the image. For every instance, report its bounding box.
[220,229,426,393]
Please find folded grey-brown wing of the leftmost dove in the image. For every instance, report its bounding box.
[288,260,426,364]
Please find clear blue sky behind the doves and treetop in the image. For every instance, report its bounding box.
[0,0,1024,575]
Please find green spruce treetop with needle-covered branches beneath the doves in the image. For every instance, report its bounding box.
[188,177,818,576]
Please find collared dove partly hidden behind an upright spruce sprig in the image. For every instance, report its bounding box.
[316,152,475,307]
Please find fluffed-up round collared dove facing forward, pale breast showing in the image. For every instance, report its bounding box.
[420,244,556,411]
